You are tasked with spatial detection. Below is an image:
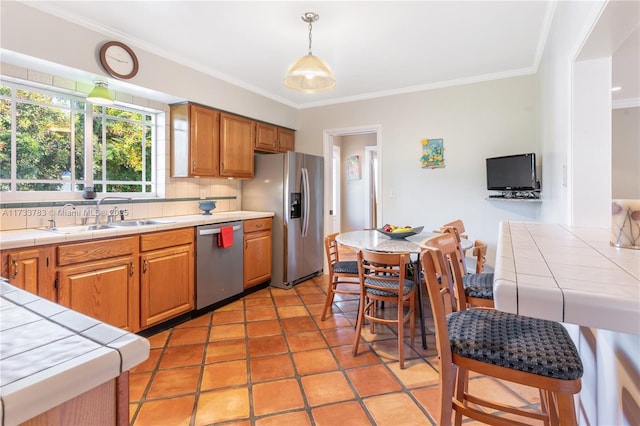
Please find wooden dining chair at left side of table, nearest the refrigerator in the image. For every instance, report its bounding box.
[320,232,360,321]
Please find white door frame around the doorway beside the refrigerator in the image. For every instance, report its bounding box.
[322,124,383,238]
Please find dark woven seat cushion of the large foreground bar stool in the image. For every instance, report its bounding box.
[447,309,583,380]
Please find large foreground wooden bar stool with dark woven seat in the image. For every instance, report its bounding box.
[420,234,583,426]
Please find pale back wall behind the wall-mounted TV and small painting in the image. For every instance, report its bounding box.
[296,76,545,264]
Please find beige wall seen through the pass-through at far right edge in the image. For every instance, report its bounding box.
[611,107,640,199]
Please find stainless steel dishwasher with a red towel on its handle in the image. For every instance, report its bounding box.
[196,221,244,309]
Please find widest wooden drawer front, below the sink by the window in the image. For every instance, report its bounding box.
[58,236,138,266]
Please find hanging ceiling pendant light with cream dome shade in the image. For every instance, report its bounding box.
[284,12,336,93]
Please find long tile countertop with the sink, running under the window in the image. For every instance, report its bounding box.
[0,211,274,250]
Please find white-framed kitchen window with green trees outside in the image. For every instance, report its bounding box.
[0,81,157,200]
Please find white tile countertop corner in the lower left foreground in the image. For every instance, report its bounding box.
[0,279,149,425]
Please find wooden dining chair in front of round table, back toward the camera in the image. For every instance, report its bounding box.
[353,250,417,369]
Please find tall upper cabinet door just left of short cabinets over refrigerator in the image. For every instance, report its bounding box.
[220,113,256,178]
